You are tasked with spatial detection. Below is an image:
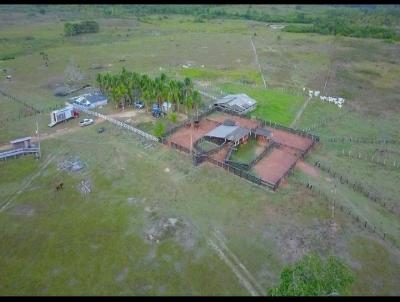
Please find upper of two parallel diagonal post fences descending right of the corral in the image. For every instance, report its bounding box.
[314,161,400,214]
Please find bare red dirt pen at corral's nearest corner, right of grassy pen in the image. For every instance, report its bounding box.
[254,149,297,184]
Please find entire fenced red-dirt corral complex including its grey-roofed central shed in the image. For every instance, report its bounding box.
[161,108,319,190]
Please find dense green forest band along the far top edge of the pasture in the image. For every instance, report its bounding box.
[4,5,400,40]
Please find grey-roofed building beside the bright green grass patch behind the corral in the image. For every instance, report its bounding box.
[213,93,257,114]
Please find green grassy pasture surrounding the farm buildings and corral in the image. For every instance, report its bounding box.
[0,9,400,295]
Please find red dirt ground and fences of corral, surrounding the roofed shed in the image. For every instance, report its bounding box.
[160,109,319,190]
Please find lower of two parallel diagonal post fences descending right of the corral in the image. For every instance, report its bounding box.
[295,180,400,249]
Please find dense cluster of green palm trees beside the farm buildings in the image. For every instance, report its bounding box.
[96,68,202,115]
